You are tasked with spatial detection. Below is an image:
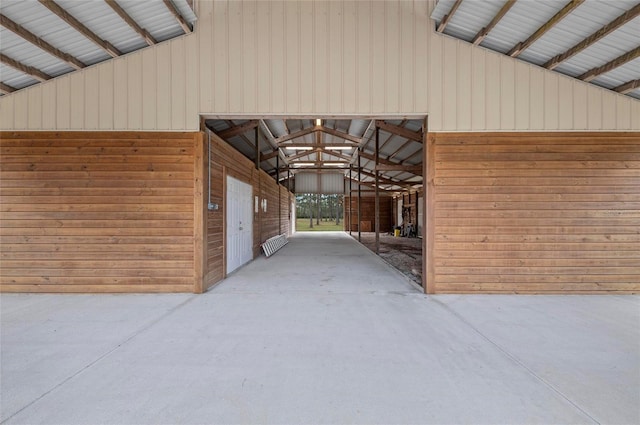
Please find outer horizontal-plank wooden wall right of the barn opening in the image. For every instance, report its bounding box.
[425,133,640,293]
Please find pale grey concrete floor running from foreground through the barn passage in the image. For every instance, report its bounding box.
[0,233,640,424]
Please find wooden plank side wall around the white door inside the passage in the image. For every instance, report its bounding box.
[203,133,293,290]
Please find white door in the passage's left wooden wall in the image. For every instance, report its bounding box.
[227,176,253,273]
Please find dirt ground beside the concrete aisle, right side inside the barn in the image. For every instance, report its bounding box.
[351,232,422,286]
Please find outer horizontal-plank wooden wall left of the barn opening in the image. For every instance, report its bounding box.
[0,132,201,292]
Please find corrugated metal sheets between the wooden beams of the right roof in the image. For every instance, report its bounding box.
[431,0,640,99]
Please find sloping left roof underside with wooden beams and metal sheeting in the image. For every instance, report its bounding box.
[0,0,196,95]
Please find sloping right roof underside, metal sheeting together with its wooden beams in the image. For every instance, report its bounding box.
[431,0,640,99]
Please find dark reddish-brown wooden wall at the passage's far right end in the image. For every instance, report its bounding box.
[343,195,394,233]
